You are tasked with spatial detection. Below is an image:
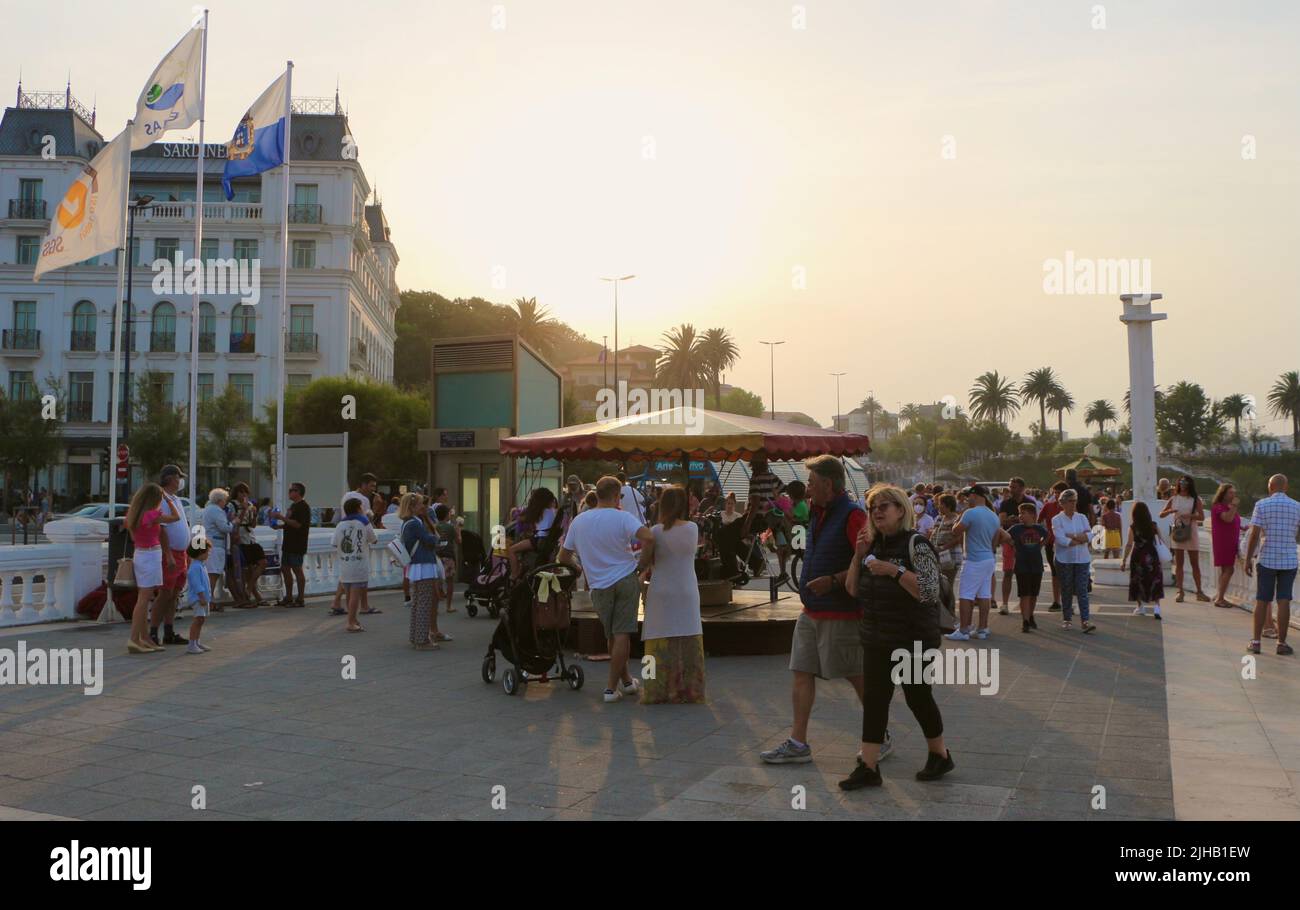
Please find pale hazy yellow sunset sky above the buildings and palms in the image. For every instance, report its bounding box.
[12,0,1300,436]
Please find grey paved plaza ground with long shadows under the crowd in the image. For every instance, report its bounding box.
[0,586,1300,820]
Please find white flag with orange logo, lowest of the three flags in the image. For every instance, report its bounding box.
[33,127,131,281]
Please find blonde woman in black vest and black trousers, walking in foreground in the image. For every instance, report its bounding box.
[840,484,954,790]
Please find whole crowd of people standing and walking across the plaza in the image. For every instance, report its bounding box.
[116,455,1300,789]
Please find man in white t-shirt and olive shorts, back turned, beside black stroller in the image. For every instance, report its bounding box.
[559,477,654,702]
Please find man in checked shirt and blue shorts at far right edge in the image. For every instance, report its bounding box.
[1245,475,1300,654]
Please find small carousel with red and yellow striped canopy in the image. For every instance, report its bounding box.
[501,407,871,654]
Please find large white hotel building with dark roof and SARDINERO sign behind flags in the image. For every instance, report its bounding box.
[0,86,399,501]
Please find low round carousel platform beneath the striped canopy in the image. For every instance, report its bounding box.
[567,589,803,657]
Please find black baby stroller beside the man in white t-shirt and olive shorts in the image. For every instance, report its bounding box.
[482,563,582,696]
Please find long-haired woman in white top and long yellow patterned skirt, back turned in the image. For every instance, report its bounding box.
[641,485,705,705]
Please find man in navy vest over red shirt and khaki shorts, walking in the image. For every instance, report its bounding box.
[759,455,892,764]
